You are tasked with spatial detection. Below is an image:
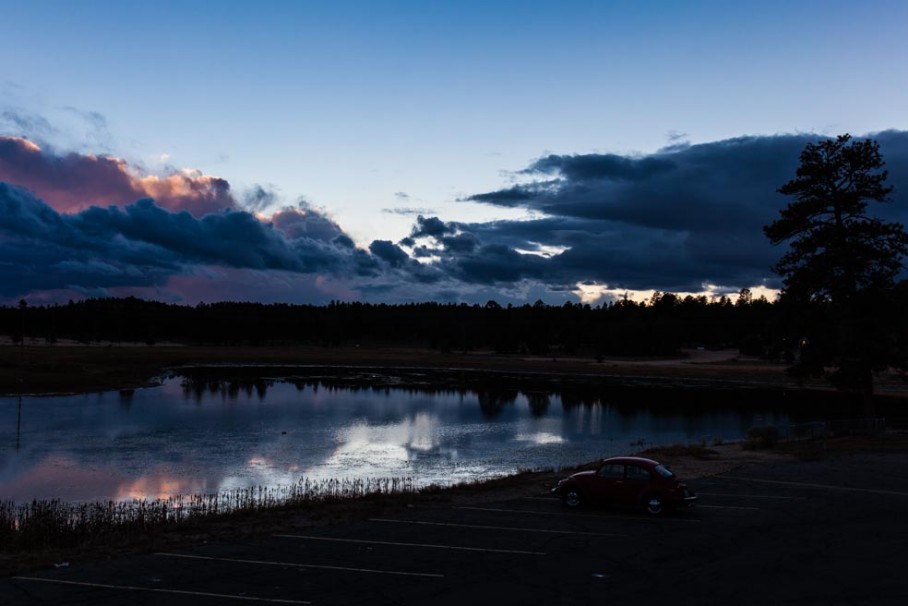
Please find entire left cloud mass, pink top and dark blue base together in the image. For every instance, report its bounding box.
[0,137,394,302]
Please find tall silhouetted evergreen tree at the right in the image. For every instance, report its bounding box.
[764,134,908,392]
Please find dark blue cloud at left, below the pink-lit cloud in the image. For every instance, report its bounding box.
[0,183,378,298]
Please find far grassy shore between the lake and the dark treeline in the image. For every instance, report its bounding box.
[0,343,908,397]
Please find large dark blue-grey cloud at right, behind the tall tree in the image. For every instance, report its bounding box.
[420,131,908,291]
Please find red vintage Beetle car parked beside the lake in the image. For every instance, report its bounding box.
[552,457,697,516]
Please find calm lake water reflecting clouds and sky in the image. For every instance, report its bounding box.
[0,379,788,502]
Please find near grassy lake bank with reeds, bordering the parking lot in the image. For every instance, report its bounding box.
[0,432,908,578]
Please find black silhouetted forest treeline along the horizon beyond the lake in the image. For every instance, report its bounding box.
[0,290,908,363]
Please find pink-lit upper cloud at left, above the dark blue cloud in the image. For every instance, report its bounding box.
[0,136,239,217]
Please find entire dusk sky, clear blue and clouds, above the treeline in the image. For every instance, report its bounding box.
[0,0,908,304]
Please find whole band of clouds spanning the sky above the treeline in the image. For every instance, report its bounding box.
[0,131,908,303]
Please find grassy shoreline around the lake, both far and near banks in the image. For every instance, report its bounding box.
[0,344,908,576]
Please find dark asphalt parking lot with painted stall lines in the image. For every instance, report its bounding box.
[0,454,908,606]
